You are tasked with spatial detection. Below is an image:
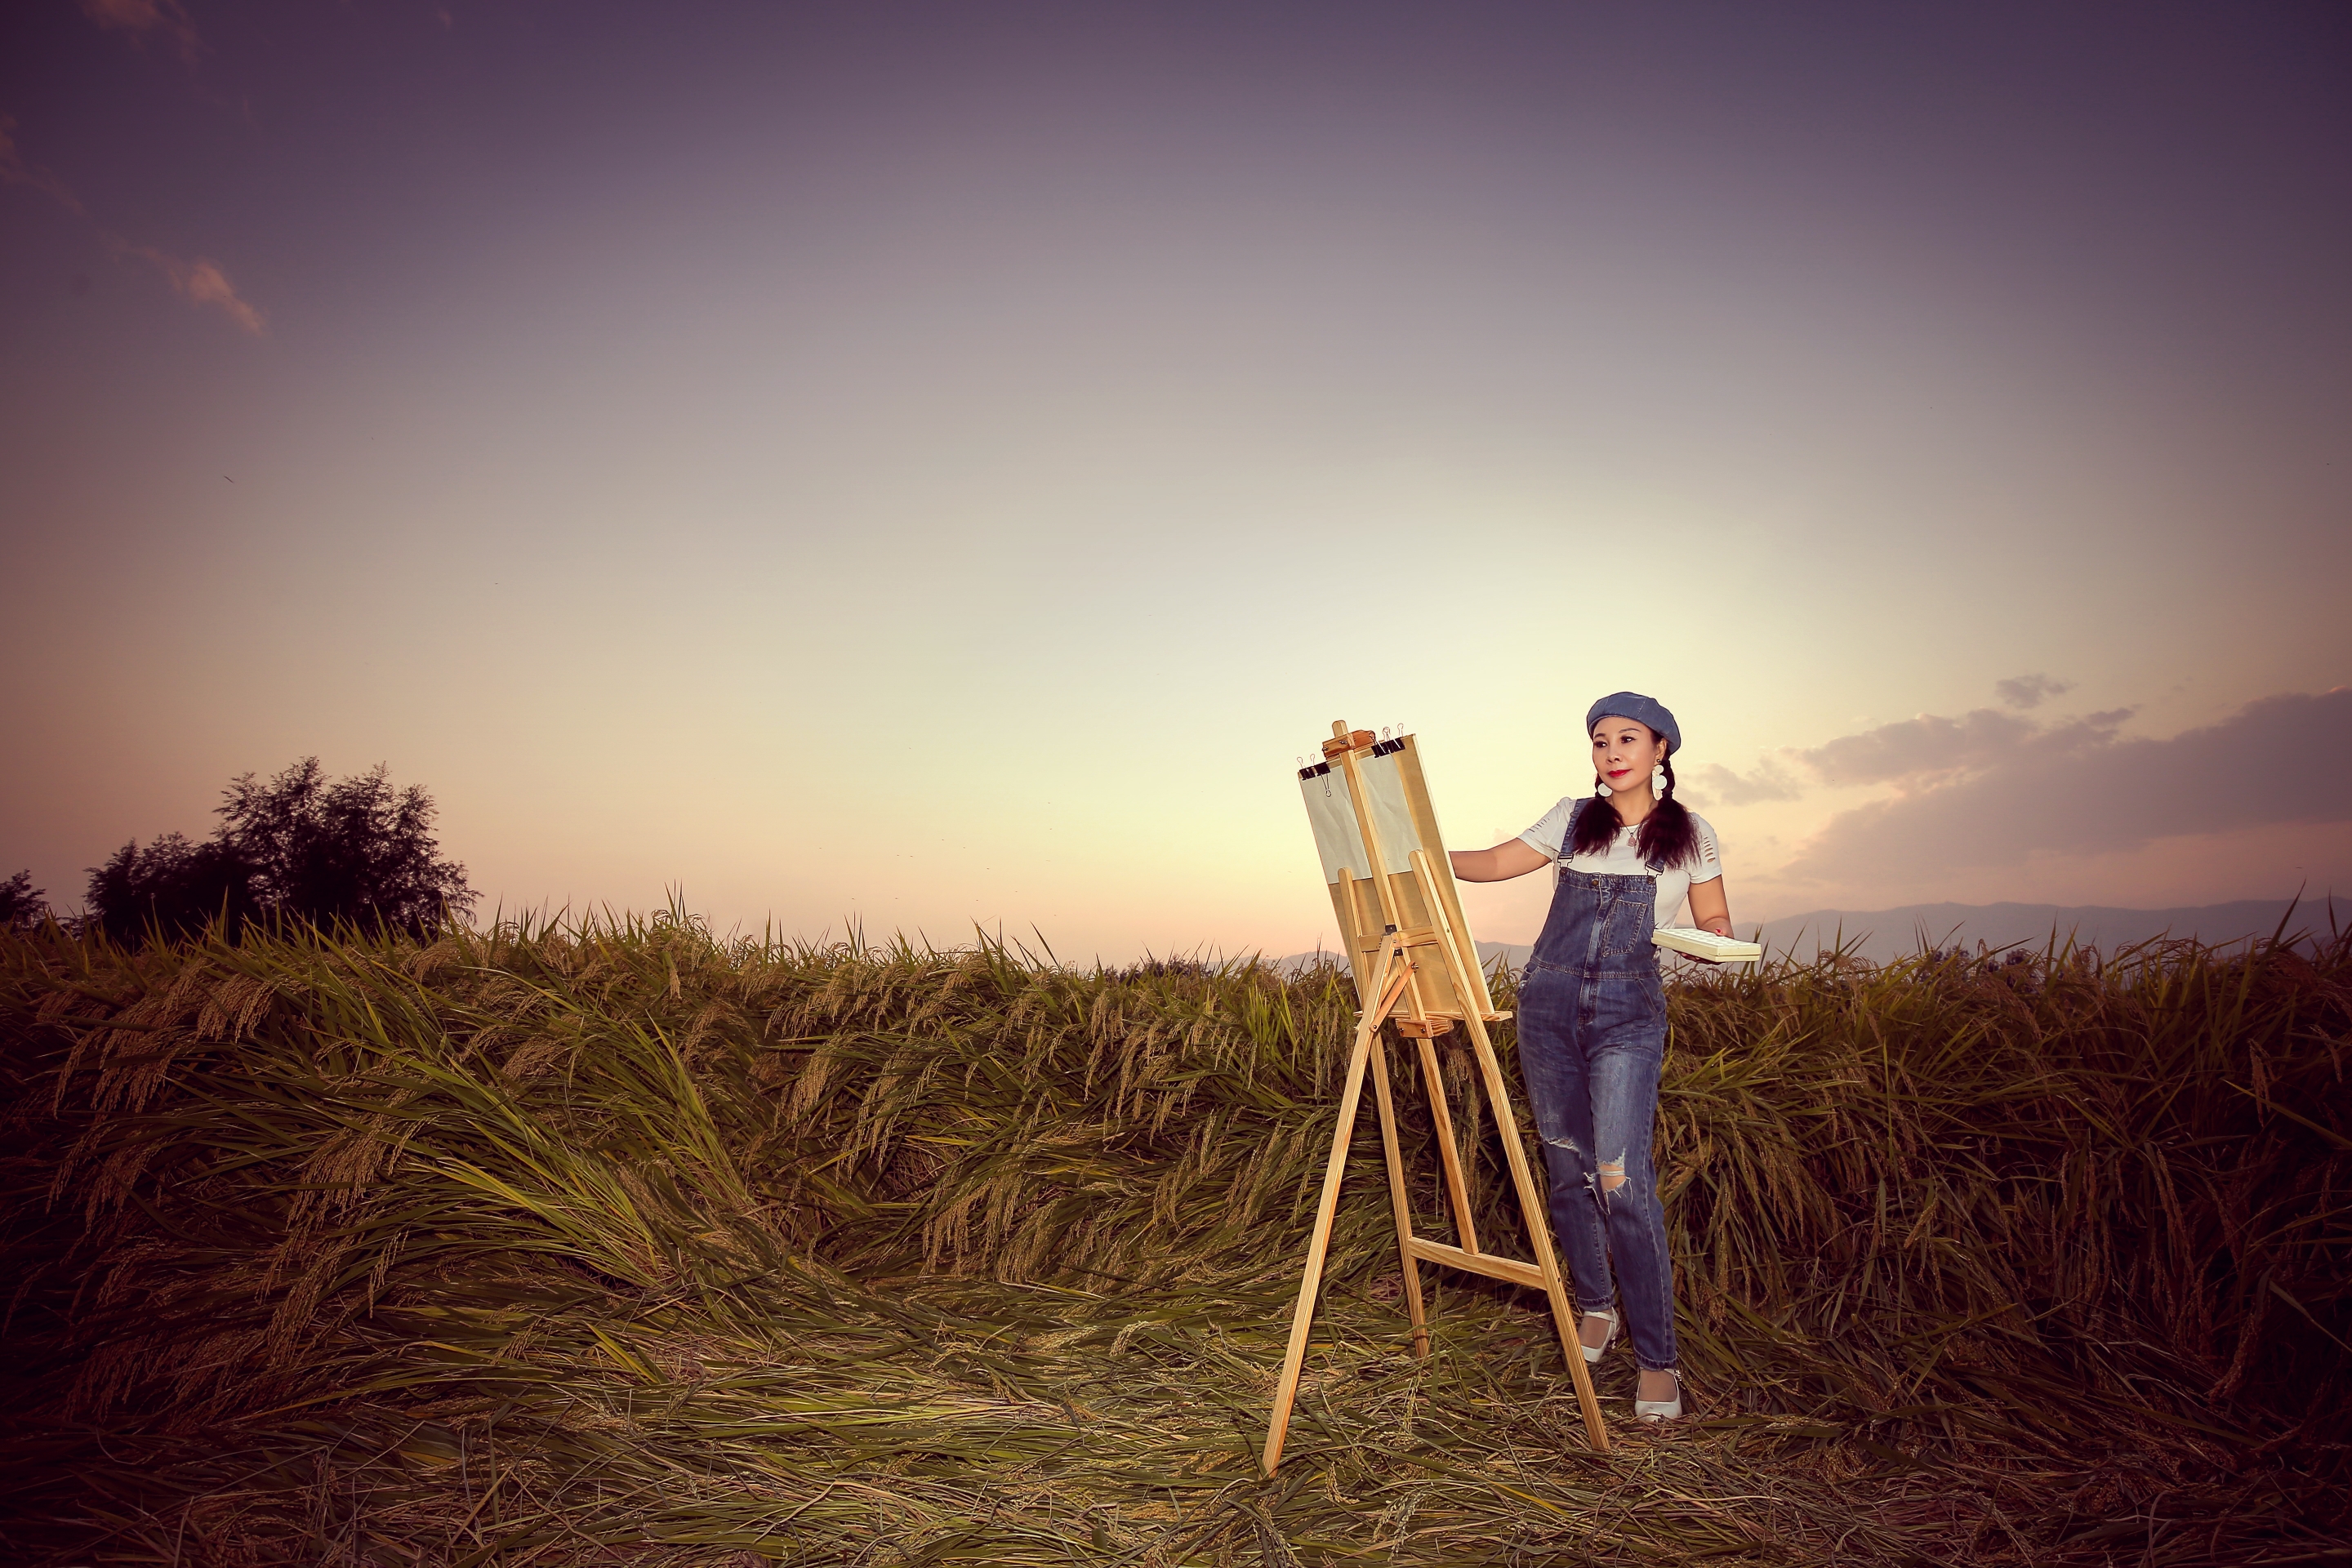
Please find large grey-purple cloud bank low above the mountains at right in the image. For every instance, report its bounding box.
[1785,687,2352,881]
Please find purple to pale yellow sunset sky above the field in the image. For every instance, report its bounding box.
[0,0,2352,959]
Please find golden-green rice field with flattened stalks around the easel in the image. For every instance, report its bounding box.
[0,917,2352,1568]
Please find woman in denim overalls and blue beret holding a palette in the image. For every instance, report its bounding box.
[1451,691,1731,1420]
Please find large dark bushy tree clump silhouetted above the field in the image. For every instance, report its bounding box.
[89,757,475,942]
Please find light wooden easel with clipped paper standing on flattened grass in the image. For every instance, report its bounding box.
[1263,722,1609,1474]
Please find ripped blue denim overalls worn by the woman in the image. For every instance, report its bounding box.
[1519,802,1675,1370]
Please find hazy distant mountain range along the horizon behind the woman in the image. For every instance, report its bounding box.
[1275,898,2352,973]
